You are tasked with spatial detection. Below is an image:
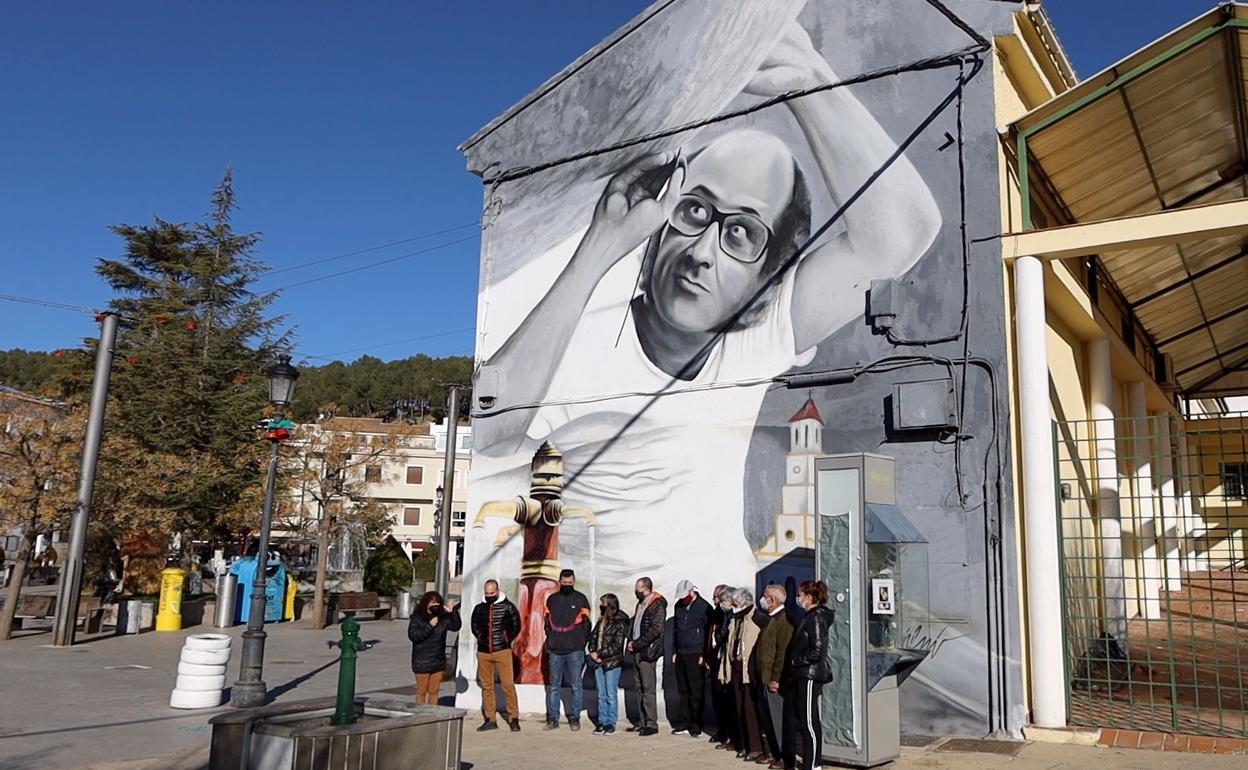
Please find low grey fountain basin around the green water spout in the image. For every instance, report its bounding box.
[208,698,467,770]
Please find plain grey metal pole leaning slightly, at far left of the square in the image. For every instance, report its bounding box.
[52,313,117,646]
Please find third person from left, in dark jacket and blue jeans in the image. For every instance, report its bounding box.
[545,569,590,730]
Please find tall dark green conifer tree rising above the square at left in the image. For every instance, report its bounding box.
[96,168,287,544]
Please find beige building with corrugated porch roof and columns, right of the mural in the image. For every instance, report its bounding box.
[993,4,1248,736]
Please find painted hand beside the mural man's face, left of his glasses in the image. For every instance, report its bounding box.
[577,150,685,271]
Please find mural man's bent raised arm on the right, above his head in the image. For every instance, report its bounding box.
[748,21,941,351]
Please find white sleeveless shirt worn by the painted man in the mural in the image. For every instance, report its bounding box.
[501,271,814,593]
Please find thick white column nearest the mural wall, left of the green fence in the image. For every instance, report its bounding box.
[1015,257,1066,728]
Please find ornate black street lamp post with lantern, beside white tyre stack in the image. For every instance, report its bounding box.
[230,356,300,708]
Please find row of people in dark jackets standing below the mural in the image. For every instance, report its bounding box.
[408,569,834,770]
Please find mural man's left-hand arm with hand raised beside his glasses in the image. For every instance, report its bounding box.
[482,152,685,451]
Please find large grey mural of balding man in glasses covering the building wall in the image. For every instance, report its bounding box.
[461,0,1021,731]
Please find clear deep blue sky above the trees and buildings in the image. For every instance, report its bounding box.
[0,0,1214,359]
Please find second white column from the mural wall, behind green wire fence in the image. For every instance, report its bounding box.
[1087,337,1127,646]
